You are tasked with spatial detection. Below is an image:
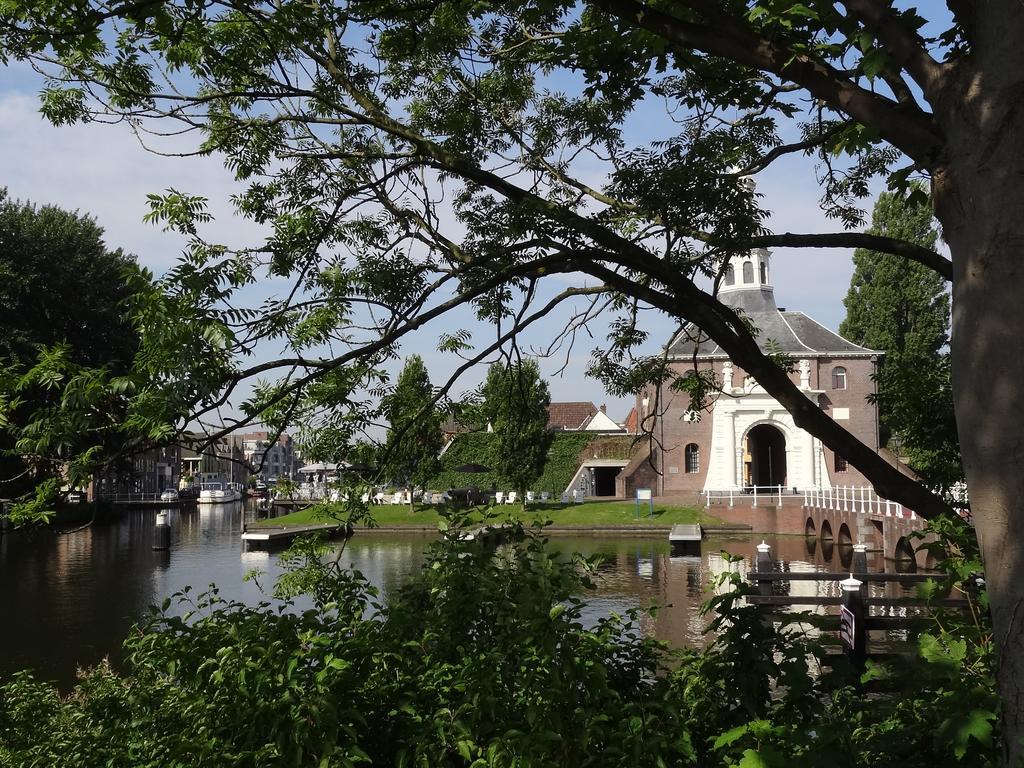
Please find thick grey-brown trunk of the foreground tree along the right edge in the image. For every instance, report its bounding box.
[933,22,1024,753]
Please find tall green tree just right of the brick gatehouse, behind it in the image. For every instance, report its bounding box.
[839,189,963,488]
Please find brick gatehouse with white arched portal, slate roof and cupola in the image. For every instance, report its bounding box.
[624,250,882,494]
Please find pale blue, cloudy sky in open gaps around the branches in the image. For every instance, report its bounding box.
[0,55,880,428]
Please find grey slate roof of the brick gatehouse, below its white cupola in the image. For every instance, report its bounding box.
[669,288,882,357]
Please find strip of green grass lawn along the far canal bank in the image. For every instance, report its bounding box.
[255,499,716,527]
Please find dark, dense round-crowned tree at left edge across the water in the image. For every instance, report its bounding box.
[0,189,138,497]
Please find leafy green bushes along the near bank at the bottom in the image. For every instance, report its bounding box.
[0,520,997,768]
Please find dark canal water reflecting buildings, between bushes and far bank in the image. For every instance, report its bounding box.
[0,504,873,687]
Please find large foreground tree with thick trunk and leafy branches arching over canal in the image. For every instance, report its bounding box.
[6,0,1024,759]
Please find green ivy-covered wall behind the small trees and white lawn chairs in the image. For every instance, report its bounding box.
[430,432,593,495]
